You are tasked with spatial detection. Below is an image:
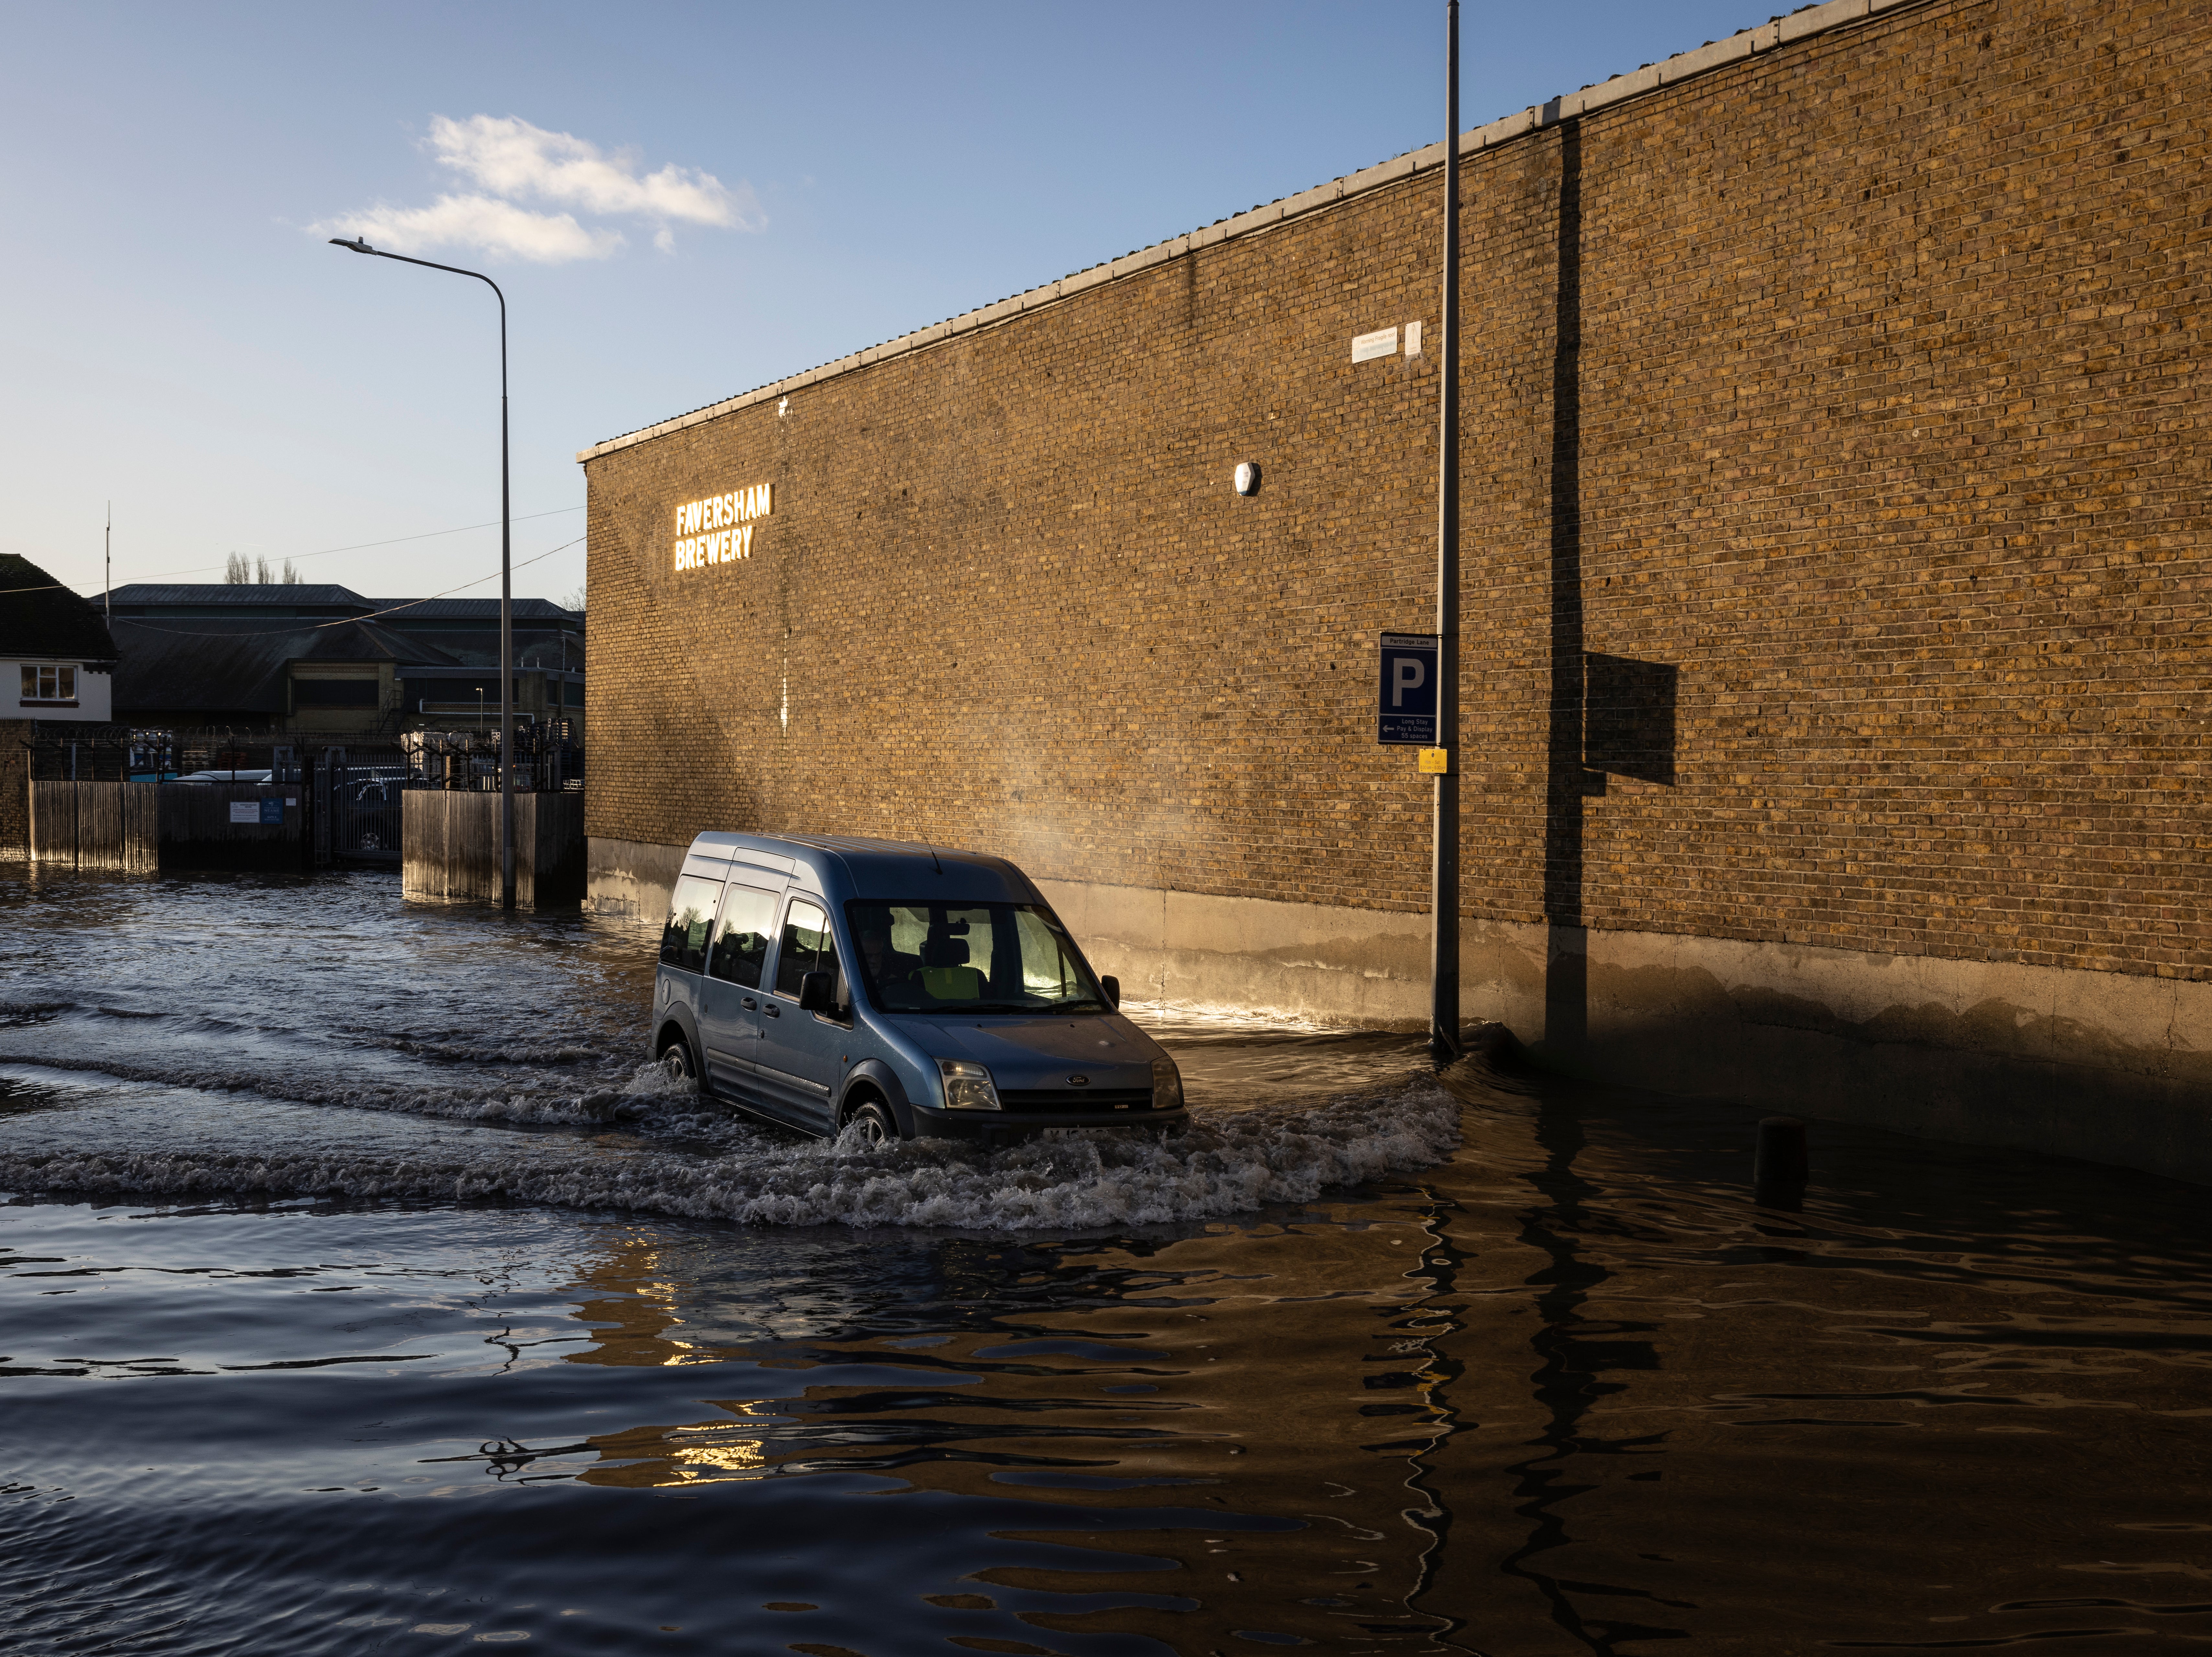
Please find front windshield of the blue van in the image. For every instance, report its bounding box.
[845,898,1113,1013]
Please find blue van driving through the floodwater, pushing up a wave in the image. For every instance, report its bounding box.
[652,834,1185,1144]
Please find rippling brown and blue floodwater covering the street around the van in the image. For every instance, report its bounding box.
[0,874,2212,1657]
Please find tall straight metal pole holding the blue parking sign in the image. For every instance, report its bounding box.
[1429,0,1460,1058]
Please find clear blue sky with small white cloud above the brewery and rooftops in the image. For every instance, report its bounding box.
[0,0,1770,597]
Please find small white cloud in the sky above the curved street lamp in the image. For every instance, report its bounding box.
[310,115,767,266]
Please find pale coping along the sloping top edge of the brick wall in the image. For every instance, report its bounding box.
[575,0,1933,462]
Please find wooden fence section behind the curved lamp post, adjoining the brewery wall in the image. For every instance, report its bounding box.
[400,788,586,909]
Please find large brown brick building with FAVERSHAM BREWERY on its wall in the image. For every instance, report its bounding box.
[582,0,2212,1177]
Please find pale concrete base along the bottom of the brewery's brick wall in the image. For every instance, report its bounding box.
[591,841,2212,1184]
